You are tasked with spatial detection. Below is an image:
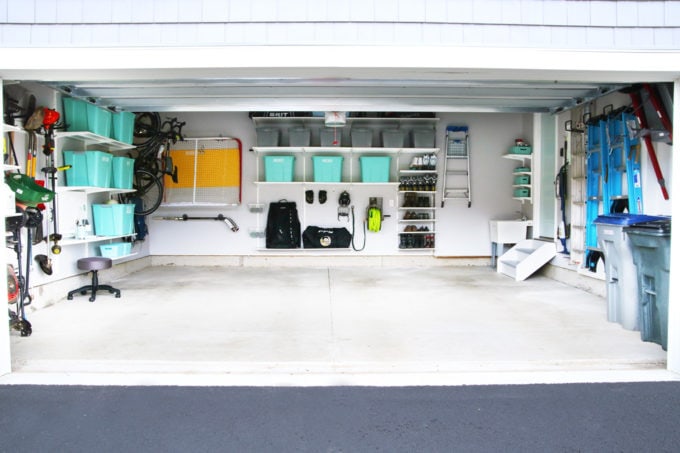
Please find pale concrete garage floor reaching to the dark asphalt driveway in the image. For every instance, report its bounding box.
[0,266,678,385]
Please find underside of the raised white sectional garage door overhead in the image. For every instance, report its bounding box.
[43,75,623,112]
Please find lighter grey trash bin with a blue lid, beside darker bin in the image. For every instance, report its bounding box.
[594,214,662,330]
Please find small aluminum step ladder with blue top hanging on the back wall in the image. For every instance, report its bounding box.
[442,126,472,208]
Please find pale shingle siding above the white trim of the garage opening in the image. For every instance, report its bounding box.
[0,0,680,50]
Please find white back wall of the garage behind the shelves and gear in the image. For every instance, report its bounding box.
[148,112,531,256]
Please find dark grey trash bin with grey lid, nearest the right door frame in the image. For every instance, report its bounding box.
[624,218,671,350]
